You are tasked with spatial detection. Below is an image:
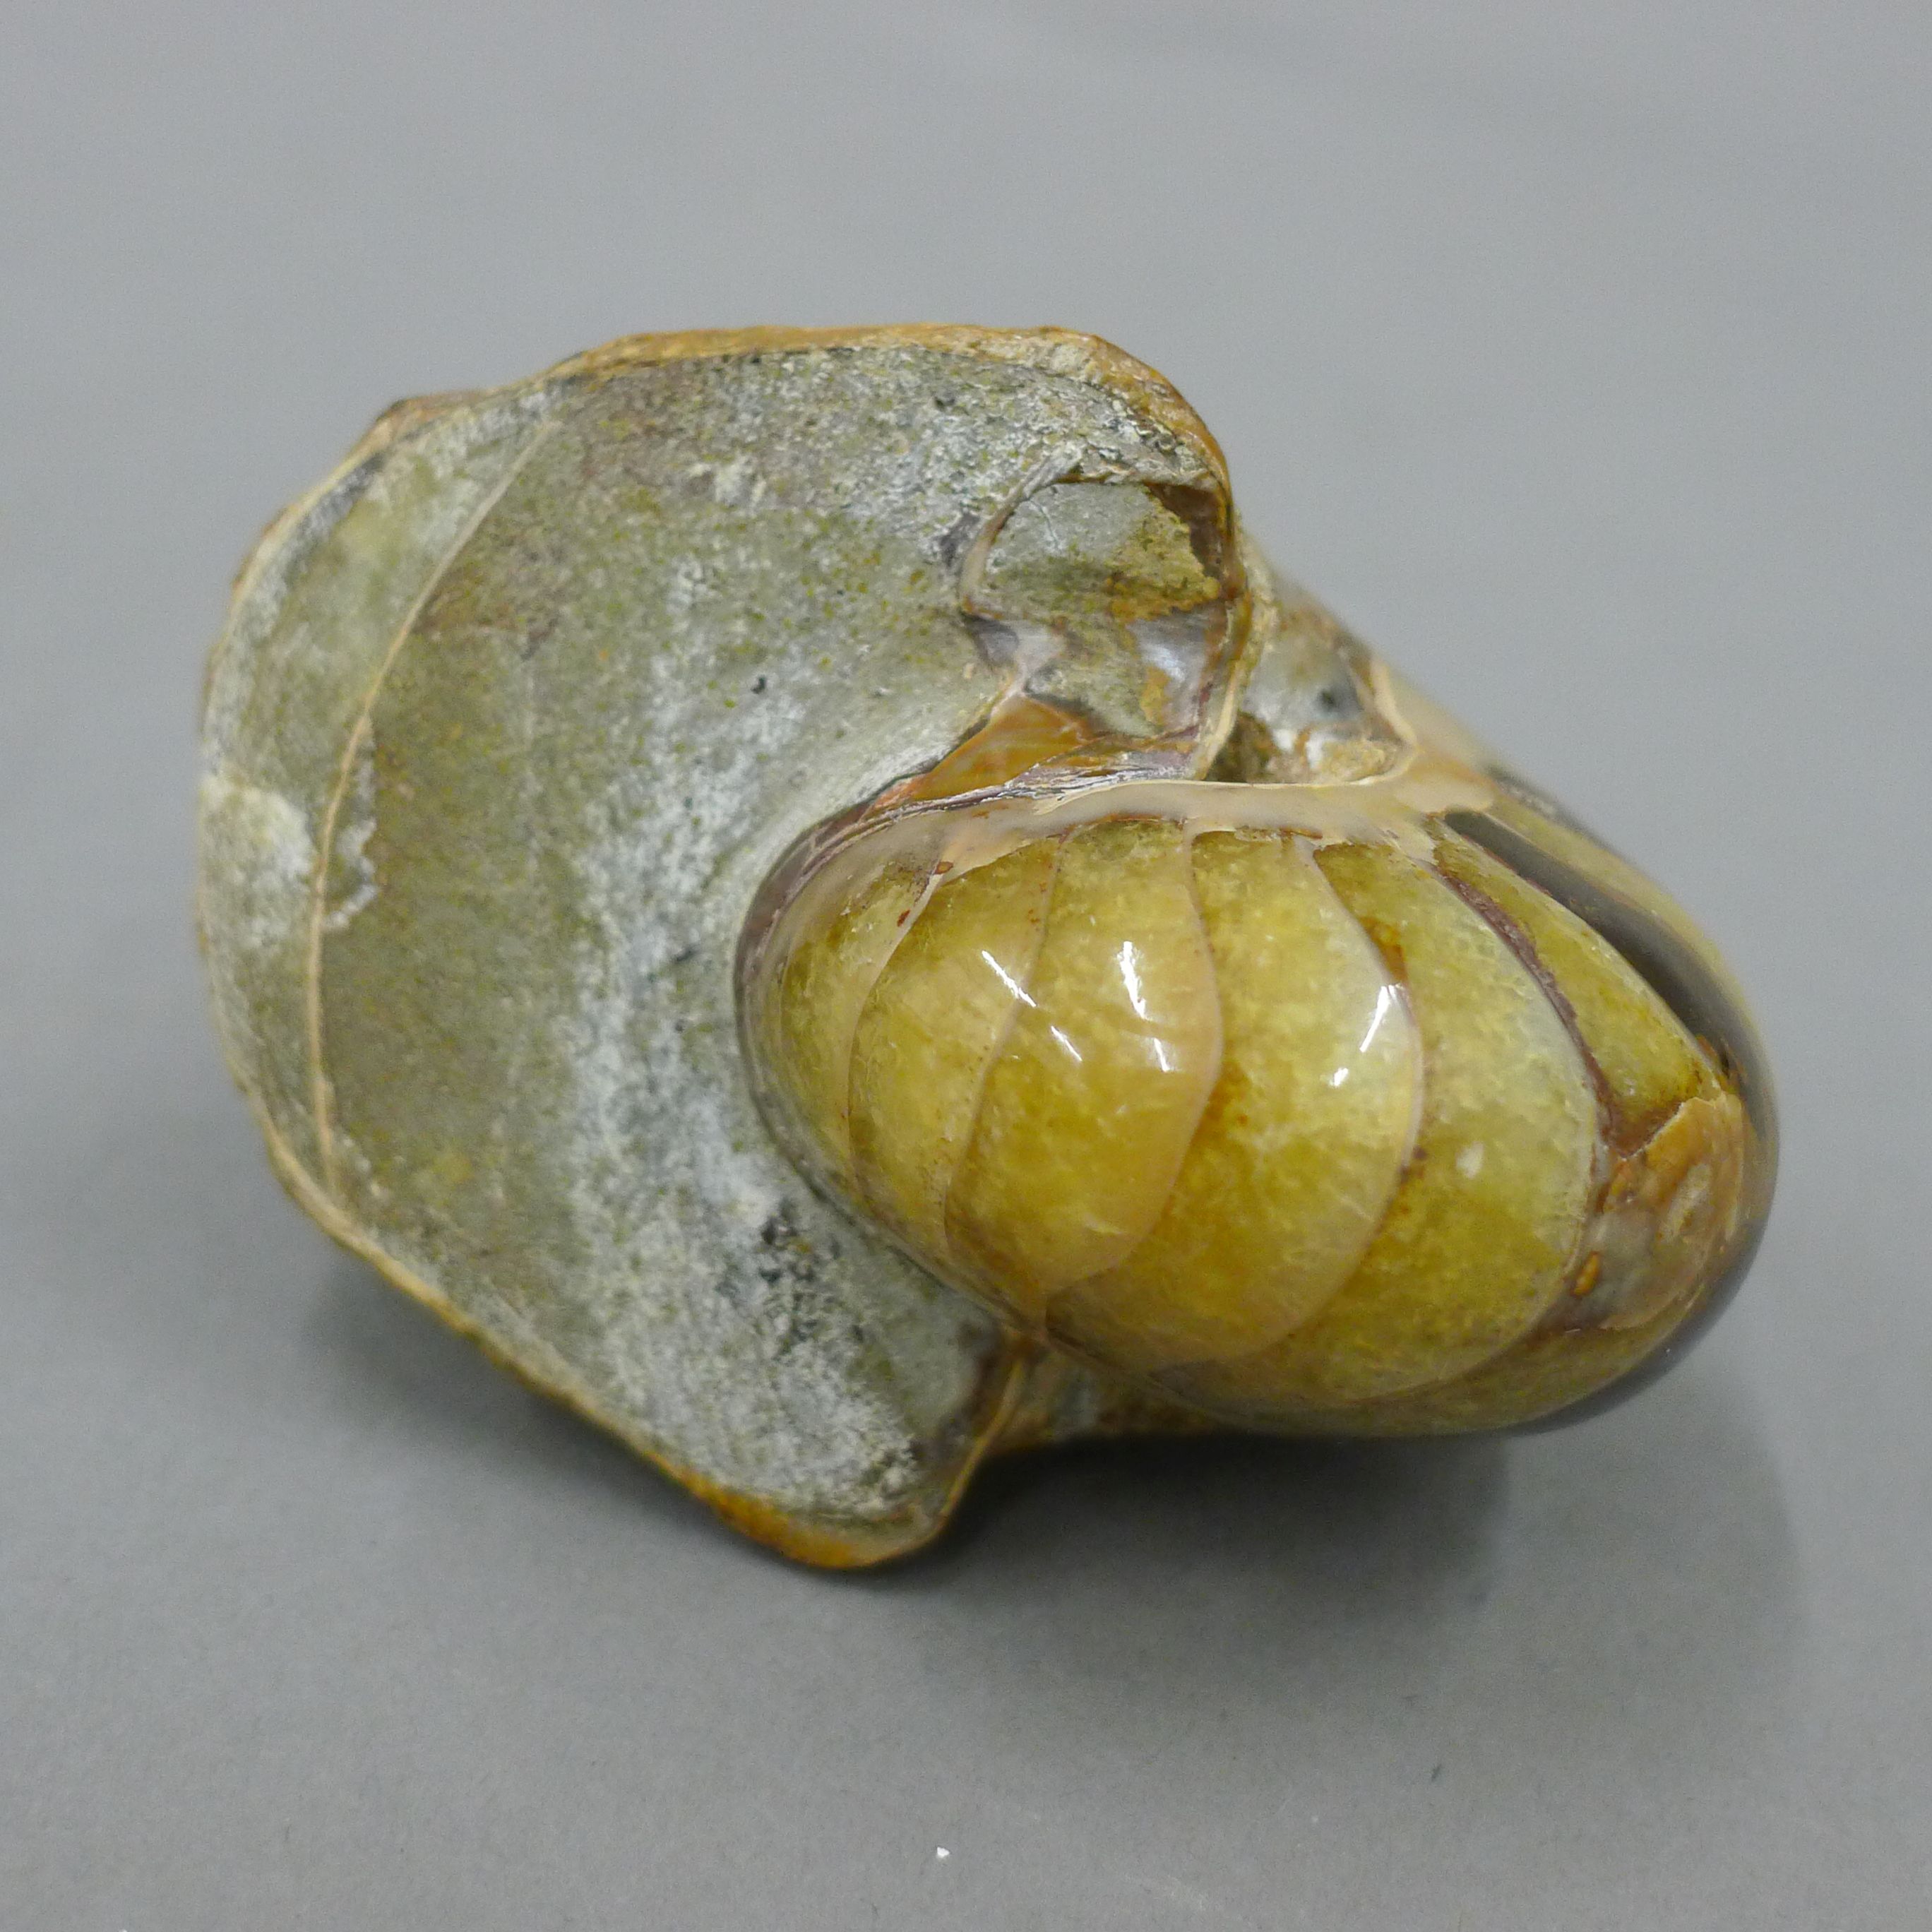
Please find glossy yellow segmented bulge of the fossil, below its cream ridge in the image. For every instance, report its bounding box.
[751,787,1767,1433]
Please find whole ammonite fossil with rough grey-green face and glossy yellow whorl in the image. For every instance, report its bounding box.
[201,328,1774,1563]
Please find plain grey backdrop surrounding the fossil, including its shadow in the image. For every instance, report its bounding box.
[0,0,1932,1932]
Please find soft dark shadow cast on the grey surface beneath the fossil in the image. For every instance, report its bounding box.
[307,1258,1801,1775]
